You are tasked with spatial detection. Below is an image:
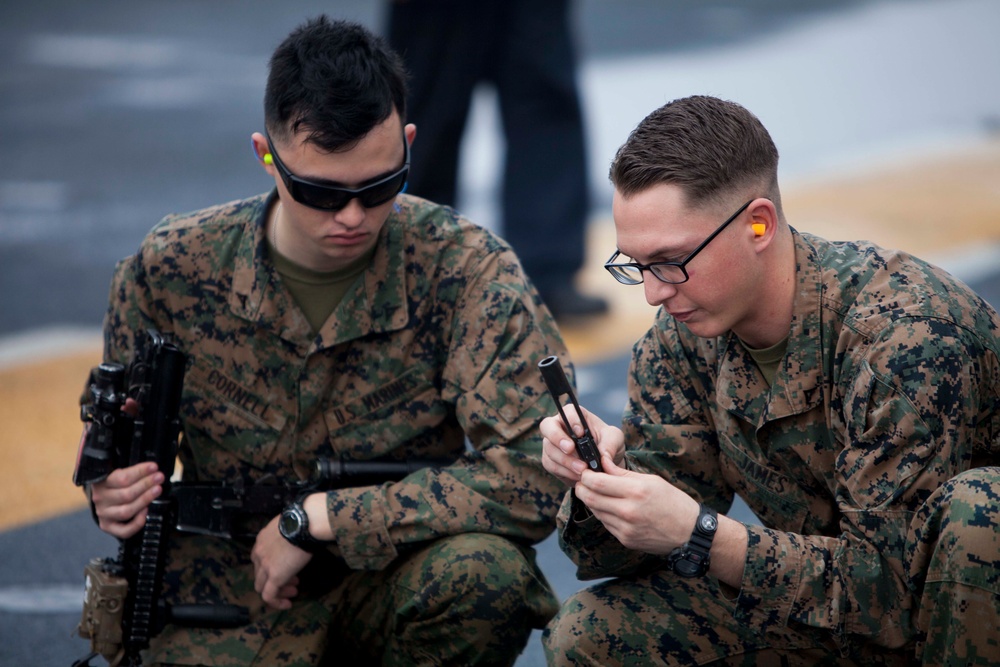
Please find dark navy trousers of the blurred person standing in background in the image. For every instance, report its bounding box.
[388,0,589,292]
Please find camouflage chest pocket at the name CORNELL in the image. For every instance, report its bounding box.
[183,361,287,479]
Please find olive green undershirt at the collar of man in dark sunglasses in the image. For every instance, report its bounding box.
[267,240,375,334]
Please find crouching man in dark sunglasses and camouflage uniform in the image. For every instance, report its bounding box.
[89,17,568,666]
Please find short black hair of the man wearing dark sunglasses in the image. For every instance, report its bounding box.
[264,15,407,152]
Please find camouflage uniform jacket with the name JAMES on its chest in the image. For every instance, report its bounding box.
[559,232,1000,646]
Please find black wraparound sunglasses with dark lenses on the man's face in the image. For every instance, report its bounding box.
[264,134,410,211]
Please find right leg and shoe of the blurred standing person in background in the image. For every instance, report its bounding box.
[494,0,607,316]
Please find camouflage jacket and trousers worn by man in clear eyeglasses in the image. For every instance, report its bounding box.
[544,98,1000,666]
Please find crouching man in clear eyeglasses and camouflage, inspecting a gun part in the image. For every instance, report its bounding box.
[541,97,1000,666]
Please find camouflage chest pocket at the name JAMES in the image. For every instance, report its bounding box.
[719,435,809,533]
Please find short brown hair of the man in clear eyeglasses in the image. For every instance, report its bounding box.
[610,95,781,211]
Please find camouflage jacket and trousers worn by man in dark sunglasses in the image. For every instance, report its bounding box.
[87,14,569,666]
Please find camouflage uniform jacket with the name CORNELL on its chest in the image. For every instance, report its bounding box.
[105,194,568,572]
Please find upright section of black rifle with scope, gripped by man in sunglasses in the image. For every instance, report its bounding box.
[73,330,249,667]
